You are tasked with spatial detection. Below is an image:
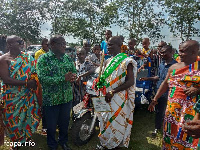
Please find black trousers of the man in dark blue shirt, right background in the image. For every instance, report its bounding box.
[155,96,167,129]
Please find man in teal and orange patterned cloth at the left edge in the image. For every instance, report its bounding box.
[0,36,40,149]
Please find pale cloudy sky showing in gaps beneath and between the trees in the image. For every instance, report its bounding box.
[41,17,200,49]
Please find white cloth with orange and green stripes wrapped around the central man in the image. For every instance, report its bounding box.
[97,57,137,149]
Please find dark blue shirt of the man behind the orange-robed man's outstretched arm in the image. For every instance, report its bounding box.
[157,59,177,97]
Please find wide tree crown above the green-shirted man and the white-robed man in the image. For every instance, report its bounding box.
[42,0,116,43]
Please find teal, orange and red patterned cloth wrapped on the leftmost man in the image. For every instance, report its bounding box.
[1,52,40,143]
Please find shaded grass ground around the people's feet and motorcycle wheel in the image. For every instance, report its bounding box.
[0,107,162,150]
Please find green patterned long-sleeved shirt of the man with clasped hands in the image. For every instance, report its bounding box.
[37,51,76,106]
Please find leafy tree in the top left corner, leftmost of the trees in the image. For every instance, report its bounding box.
[0,0,42,43]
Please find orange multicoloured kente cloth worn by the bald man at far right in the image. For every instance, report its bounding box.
[163,61,200,150]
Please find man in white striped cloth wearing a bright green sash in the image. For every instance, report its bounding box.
[96,36,137,149]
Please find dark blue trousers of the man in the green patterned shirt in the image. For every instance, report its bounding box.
[44,101,72,148]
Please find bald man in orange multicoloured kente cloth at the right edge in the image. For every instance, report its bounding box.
[149,40,200,150]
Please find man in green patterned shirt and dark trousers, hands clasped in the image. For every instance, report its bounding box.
[37,36,76,150]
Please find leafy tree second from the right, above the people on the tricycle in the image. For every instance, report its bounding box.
[113,0,164,42]
